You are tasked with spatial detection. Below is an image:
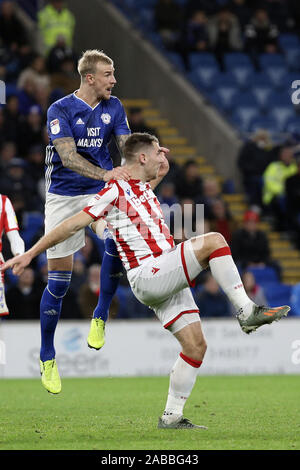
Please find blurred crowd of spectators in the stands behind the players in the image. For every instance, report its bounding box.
[0,0,300,319]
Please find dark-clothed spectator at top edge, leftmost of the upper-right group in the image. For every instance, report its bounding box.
[154,0,182,49]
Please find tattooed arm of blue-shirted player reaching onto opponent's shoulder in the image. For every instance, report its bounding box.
[53,137,130,181]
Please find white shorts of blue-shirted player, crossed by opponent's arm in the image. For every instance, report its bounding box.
[45,193,94,259]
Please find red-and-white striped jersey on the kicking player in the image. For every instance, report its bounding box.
[84,180,175,270]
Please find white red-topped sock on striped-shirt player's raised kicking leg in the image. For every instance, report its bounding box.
[209,247,255,318]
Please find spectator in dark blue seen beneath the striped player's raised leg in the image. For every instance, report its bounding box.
[194,272,231,318]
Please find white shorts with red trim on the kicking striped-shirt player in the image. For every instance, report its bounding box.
[127,240,202,328]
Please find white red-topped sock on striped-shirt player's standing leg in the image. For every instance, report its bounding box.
[162,353,202,424]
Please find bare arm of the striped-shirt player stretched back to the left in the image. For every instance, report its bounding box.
[0,211,94,276]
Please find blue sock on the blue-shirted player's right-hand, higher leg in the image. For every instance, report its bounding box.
[93,232,122,322]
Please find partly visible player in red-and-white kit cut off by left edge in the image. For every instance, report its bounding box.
[0,194,25,317]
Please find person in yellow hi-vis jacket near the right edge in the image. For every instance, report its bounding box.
[263,146,298,231]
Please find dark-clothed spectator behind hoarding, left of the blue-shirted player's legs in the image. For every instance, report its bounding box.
[6,267,43,320]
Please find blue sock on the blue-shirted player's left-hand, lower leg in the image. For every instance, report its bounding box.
[40,271,72,362]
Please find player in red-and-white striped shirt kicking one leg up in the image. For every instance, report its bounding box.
[3,134,290,429]
